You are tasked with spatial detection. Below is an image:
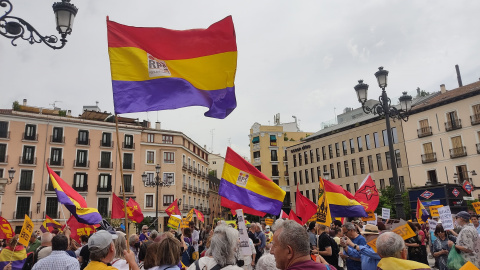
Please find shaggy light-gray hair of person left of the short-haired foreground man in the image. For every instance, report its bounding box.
[208,225,238,267]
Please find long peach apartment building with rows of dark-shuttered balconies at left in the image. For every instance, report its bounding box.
[0,105,209,231]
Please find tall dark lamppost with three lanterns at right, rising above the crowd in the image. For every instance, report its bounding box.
[354,67,412,219]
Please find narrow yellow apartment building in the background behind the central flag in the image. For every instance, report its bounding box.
[248,114,312,210]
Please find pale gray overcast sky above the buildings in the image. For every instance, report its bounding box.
[0,0,480,157]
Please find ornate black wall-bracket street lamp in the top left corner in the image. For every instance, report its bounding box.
[0,0,78,49]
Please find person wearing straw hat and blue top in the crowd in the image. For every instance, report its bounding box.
[345,224,382,270]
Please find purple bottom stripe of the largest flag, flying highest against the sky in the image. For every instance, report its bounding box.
[112,78,237,119]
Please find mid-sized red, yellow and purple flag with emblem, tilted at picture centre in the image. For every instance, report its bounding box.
[218,147,286,215]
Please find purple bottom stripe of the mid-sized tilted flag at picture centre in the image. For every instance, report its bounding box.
[218,178,283,215]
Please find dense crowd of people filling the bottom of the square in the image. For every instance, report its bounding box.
[0,211,480,270]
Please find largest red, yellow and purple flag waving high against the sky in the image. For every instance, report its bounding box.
[107,16,237,119]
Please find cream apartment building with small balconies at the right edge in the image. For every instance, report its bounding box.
[404,82,480,199]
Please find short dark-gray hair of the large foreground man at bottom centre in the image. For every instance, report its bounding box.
[276,220,310,256]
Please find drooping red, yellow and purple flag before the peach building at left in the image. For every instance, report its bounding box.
[46,164,102,225]
